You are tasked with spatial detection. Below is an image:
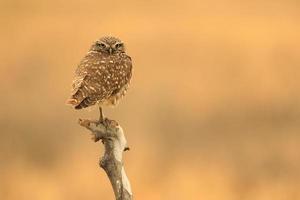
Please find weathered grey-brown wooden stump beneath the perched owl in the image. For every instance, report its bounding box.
[79,118,132,200]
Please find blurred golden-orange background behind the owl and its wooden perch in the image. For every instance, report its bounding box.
[0,0,300,200]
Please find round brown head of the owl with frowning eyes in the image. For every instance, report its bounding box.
[91,36,125,54]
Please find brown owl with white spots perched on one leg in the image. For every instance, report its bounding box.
[67,37,132,120]
